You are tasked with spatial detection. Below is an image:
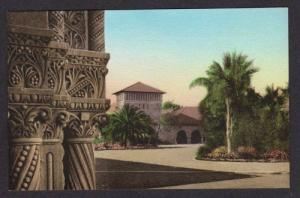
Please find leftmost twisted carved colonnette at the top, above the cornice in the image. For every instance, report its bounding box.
[48,11,65,42]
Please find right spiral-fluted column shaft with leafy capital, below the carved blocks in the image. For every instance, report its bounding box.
[64,113,103,190]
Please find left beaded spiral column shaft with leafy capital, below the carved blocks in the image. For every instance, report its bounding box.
[8,105,49,191]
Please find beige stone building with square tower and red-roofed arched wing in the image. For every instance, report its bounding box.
[114,82,205,144]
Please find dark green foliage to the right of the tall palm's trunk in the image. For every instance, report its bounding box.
[232,86,289,152]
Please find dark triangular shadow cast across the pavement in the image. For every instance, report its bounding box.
[96,158,251,189]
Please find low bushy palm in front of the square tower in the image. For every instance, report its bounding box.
[109,104,154,148]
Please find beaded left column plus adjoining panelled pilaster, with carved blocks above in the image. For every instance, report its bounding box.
[8,26,69,190]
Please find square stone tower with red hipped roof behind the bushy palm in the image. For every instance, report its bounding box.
[114,82,165,124]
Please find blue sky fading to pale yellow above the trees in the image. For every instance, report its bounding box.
[105,8,288,106]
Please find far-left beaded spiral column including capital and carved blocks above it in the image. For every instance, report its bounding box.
[7,26,51,190]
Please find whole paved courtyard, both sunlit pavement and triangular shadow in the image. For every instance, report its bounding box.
[95,144,289,189]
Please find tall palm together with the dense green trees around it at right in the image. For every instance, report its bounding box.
[190,53,289,155]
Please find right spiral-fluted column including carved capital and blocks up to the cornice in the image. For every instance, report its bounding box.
[64,49,109,190]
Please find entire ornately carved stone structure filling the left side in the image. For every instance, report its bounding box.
[7,10,110,191]
